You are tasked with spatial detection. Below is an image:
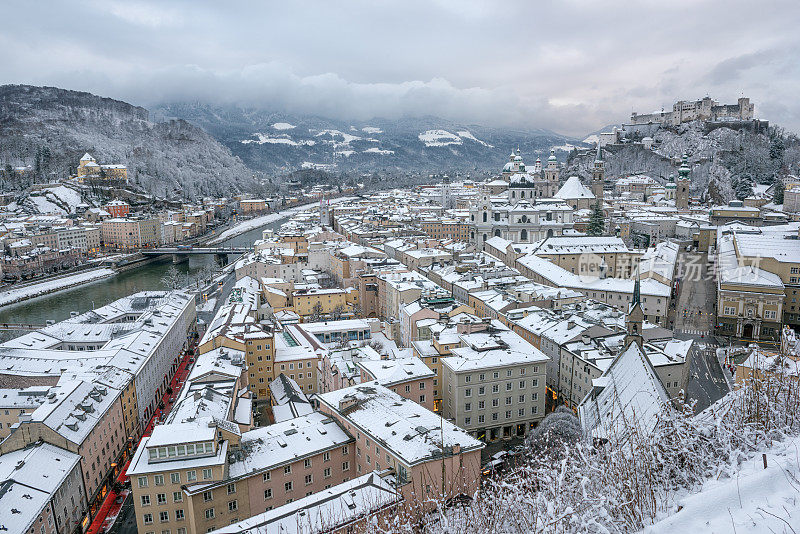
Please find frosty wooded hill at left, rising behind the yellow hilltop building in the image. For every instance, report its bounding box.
[0,85,256,197]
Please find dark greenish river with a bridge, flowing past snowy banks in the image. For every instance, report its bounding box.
[0,219,286,332]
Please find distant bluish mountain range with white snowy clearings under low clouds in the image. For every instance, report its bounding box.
[152,103,585,173]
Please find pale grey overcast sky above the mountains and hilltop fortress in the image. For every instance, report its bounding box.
[0,0,800,136]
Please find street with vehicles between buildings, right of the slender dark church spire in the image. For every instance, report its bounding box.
[673,248,729,413]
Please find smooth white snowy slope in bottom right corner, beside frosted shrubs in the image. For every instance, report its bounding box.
[644,436,800,534]
